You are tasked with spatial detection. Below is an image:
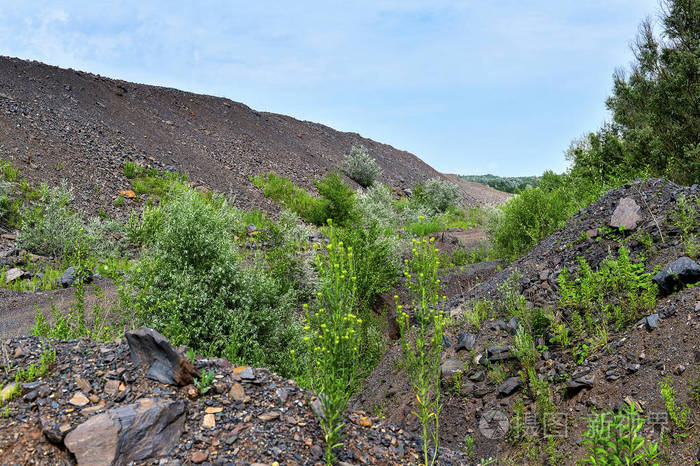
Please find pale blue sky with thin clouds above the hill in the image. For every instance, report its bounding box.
[0,0,658,176]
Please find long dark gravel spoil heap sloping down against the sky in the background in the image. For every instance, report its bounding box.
[0,57,499,215]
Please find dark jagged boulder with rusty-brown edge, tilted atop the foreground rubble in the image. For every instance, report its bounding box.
[126,327,199,386]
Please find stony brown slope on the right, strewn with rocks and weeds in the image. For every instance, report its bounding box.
[353,179,700,465]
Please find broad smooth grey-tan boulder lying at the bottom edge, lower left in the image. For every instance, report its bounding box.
[64,398,185,466]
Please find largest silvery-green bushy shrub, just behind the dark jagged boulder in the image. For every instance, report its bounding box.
[129,191,298,375]
